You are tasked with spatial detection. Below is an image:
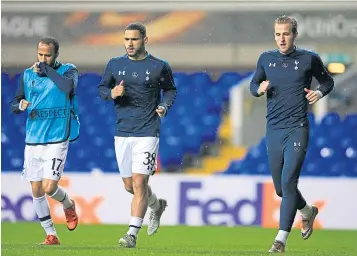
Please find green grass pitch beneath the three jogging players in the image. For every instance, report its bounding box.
[1,223,357,256]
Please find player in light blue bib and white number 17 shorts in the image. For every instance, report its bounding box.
[11,37,79,245]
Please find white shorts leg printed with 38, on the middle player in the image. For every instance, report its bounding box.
[132,137,159,175]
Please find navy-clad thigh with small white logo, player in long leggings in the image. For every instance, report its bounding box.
[283,127,309,182]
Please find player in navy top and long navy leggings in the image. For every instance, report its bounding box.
[250,15,334,253]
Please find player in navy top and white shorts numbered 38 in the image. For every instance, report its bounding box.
[99,23,176,248]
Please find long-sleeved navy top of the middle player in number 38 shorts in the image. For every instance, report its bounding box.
[98,54,176,137]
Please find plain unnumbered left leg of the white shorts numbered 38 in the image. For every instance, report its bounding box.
[114,136,132,178]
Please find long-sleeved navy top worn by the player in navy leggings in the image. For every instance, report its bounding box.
[250,48,334,129]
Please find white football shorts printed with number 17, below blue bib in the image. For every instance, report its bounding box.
[22,141,69,181]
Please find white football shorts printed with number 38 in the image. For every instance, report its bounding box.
[114,136,159,178]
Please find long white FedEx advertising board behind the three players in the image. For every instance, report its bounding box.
[1,173,357,229]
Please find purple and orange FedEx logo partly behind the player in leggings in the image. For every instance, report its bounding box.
[178,181,323,228]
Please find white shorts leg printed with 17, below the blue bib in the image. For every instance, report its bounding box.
[42,141,69,182]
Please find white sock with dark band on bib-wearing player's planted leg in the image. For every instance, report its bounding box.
[33,196,57,236]
